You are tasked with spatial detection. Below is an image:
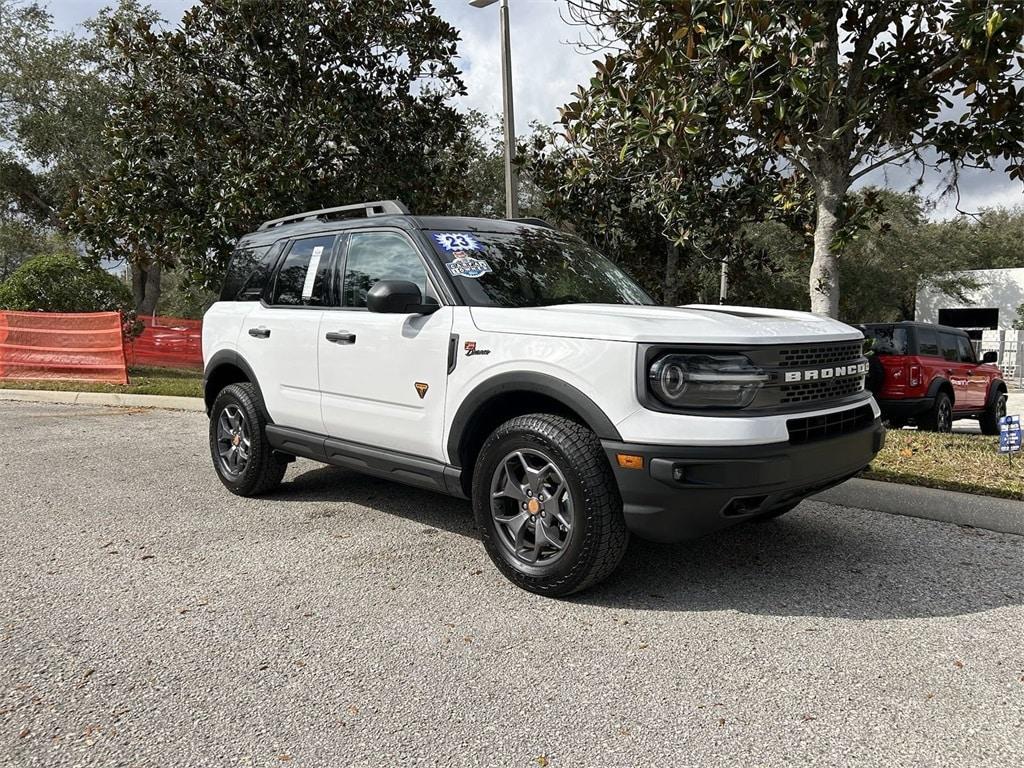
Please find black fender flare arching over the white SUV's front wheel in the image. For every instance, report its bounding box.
[447,371,623,464]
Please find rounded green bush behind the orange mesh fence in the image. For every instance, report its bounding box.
[0,253,133,314]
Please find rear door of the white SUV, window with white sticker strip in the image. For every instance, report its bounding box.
[239,234,337,434]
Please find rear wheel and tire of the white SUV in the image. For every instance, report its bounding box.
[210,382,288,497]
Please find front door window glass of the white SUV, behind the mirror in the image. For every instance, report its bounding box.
[341,232,436,307]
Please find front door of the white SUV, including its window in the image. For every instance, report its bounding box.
[317,229,453,461]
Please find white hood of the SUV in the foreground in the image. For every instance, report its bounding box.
[471,304,862,344]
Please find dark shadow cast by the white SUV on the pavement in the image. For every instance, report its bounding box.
[284,467,1024,618]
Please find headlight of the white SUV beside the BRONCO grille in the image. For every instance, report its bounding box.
[647,354,770,409]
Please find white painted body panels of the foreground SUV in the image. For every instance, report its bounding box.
[203,302,879,463]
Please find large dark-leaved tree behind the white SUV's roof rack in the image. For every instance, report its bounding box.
[76,0,466,296]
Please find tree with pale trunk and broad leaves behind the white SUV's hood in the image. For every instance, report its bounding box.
[563,0,1024,316]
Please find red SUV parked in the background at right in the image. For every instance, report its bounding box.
[858,323,1007,434]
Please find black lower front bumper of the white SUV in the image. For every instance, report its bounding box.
[602,418,885,542]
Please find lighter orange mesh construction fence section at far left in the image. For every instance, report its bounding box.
[0,311,128,384]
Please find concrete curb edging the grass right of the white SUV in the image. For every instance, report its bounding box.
[811,478,1024,536]
